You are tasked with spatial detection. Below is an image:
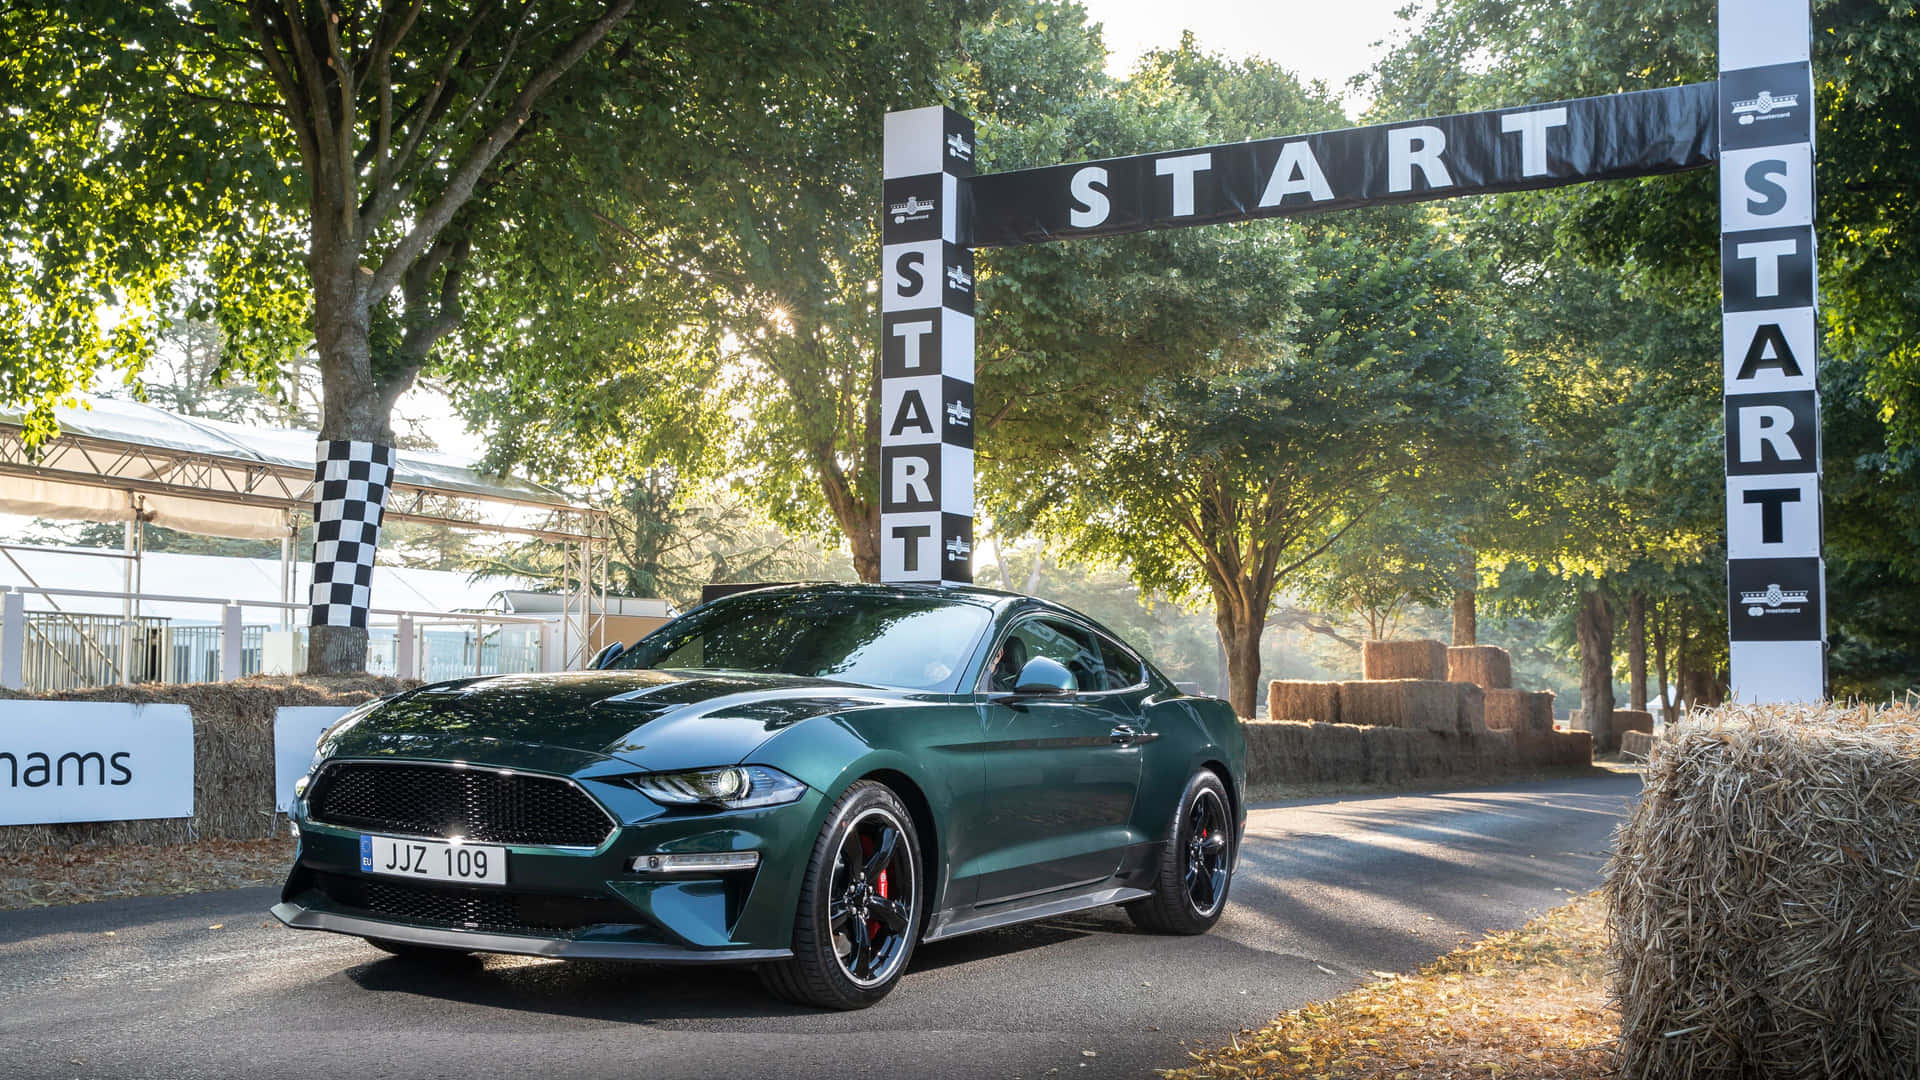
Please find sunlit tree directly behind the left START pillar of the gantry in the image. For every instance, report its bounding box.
[461,2,1292,580]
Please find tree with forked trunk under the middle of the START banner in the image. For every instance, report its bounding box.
[1006,199,1513,717]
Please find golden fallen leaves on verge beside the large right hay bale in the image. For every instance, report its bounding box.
[1162,896,1620,1080]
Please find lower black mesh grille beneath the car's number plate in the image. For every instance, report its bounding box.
[313,872,637,934]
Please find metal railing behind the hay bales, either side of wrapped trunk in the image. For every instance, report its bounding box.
[0,586,551,690]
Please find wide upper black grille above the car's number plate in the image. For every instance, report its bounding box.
[309,761,612,847]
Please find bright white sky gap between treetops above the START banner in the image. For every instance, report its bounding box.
[1081,0,1413,115]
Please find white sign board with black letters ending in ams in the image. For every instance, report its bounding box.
[0,701,194,824]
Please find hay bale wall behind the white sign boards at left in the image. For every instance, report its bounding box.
[0,675,419,853]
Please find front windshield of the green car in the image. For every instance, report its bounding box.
[612,592,993,690]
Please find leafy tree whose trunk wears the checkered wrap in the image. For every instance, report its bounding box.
[0,0,944,671]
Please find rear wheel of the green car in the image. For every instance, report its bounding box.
[1127,771,1235,934]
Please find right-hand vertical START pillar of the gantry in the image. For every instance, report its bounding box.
[1718,0,1826,701]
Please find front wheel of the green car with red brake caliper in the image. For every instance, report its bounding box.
[760,780,927,1009]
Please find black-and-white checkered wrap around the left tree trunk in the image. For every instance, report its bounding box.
[309,438,394,626]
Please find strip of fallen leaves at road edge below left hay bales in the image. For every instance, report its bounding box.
[0,838,294,911]
